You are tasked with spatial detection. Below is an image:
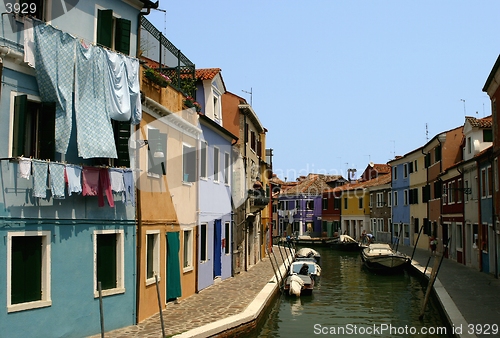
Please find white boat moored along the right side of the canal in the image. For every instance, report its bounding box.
[361,243,411,272]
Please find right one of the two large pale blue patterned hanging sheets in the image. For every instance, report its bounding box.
[75,43,118,159]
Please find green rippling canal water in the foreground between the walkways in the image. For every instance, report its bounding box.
[248,248,452,337]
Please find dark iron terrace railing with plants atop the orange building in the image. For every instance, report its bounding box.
[140,16,196,99]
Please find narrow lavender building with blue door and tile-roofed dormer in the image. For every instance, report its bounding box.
[196,68,238,291]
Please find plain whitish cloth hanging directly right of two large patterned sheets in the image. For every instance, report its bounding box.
[105,49,131,121]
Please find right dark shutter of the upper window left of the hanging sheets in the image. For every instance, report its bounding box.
[38,102,56,161]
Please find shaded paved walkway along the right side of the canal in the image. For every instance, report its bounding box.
[398,246,500,337]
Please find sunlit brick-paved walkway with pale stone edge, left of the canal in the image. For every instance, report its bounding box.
[92,249,292,338]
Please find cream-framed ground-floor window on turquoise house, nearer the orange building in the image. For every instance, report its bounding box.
[93,230,125,297]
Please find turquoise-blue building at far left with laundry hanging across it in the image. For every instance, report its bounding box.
[0,0,157,337]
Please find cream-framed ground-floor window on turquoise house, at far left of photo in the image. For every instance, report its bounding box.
[7,231,52,312]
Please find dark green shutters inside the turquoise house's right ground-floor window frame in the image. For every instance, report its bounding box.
[96,234,117,290]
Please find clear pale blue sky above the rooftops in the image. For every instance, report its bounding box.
[147,0,500,181]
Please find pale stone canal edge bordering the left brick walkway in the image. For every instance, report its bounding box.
[174,254,294,338]
